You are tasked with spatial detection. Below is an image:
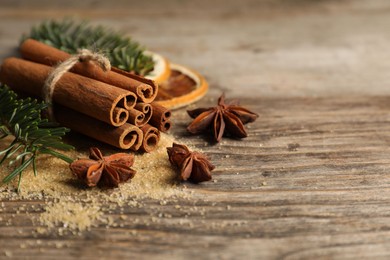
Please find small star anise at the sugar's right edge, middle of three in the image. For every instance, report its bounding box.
[167,143,215,183]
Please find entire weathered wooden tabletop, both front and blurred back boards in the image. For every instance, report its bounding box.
[0,0,390,259]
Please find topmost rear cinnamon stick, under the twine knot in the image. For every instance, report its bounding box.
[20,39,158,103]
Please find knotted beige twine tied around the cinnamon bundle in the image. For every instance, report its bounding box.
[43,49,111,122]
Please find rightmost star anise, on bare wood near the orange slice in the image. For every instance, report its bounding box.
[187,95,258,142]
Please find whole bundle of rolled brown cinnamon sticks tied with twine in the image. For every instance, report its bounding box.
[0,39,171,152]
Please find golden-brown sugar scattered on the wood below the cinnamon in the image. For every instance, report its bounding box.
[0,133,191,233]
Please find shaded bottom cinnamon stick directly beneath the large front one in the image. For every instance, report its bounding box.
[54,105,143,151]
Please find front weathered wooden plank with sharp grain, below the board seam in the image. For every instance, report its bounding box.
[0,97,390,259]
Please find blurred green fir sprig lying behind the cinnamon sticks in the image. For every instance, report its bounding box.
[23,19,154,76]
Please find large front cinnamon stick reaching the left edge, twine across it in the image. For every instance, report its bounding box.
[0,58,132,126]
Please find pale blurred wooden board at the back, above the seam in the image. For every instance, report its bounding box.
[0,0,390,96]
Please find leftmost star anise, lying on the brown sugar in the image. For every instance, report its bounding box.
[70,147,136,187]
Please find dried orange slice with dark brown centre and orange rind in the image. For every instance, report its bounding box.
[156,63,208,109]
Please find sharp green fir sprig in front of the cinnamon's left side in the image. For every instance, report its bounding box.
[0,84,73,190]
